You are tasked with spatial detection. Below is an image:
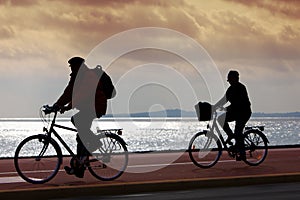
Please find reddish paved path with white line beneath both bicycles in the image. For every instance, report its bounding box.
[0,148,300,199]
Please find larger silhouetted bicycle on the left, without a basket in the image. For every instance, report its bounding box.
[14,106,128,184]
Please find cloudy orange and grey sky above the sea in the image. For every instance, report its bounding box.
[0,0,300,118]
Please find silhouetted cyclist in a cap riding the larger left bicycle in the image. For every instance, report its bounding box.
[53,57,107,178]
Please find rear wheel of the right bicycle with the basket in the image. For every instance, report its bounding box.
[244,130,268,166]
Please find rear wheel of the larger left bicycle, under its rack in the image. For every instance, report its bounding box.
[88,134,128,181]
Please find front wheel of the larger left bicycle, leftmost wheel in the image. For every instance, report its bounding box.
[14,135,62,184]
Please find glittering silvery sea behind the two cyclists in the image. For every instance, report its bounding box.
[0,117,300,158]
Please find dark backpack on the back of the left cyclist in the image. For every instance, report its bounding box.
[94,65,116,99]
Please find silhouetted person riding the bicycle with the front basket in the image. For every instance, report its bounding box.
[213,70,252,160]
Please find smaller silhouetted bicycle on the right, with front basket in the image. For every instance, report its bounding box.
[188,105,269,168]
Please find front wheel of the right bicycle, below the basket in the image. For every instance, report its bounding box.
[188,131,222,168]
